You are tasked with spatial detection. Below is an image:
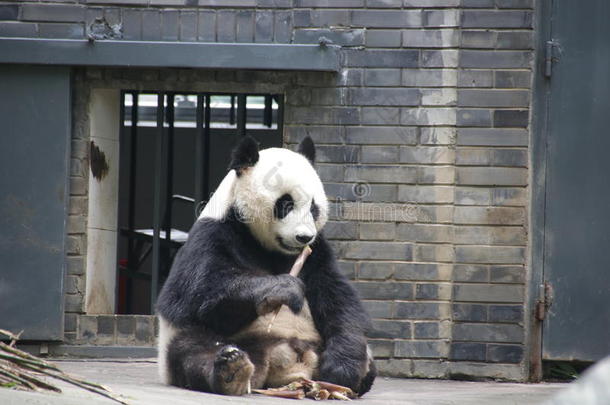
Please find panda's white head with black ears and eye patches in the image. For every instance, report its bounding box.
[230,137,328,255]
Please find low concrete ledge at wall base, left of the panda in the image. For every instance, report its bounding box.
[49,345,157,359]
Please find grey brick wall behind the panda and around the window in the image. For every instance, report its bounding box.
[0,0,534,380]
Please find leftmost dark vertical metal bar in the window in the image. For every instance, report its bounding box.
[126,91,139,314]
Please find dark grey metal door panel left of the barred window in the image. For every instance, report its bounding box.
[0,65,71,340]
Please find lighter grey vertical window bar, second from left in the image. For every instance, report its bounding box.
[150,92,165,314]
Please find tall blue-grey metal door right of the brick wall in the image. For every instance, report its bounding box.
[542,0,610,361]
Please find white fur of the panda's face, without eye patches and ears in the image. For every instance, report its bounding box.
[234,148,328,254]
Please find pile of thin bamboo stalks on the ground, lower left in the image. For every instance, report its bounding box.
[0,329,127,405]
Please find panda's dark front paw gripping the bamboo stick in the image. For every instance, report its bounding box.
[256,274,305,316]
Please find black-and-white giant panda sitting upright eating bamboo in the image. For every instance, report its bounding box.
[156,137,376,395]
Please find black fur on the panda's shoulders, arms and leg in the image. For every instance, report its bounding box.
[157,209,374,395]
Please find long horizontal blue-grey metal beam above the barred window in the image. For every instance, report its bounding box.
[0,38,341,72]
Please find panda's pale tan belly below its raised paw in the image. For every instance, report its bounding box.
[231,301,321,388]
